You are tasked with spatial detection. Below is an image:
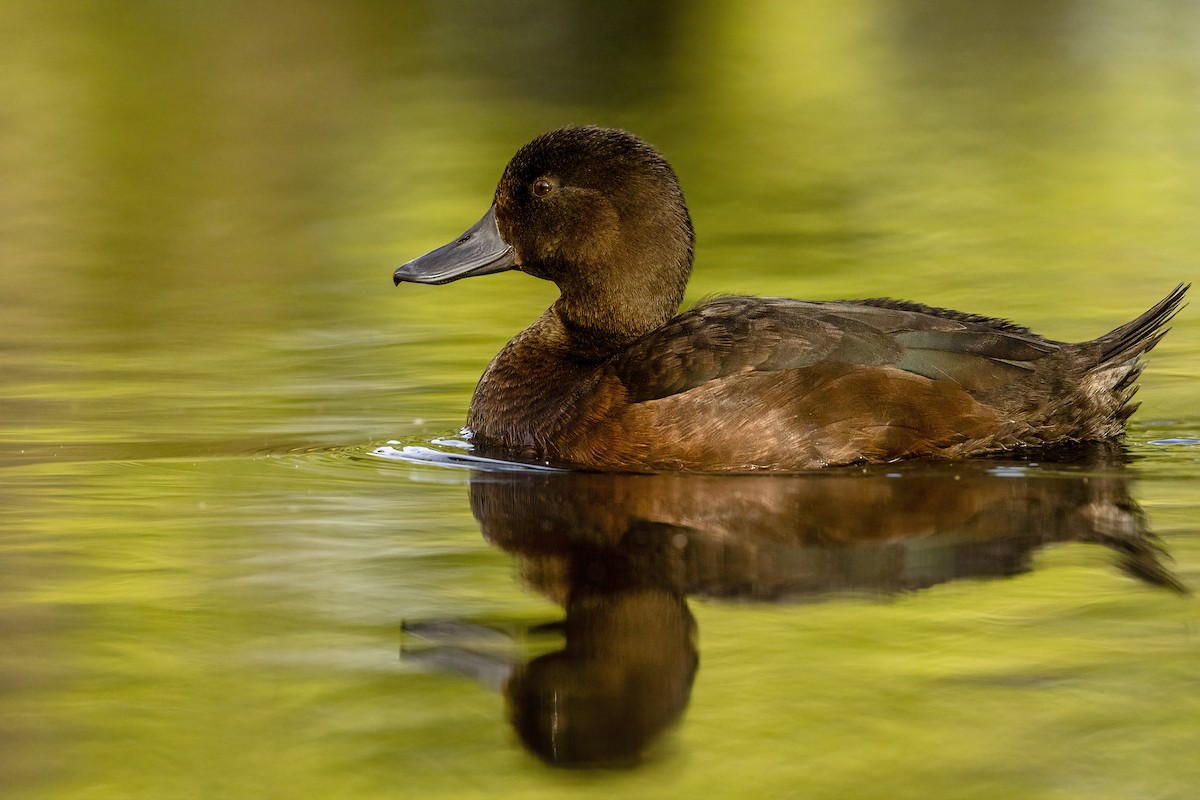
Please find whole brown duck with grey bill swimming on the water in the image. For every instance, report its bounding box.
[394,126,1189,473]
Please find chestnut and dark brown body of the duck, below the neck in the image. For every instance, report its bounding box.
[472,288,1184,470]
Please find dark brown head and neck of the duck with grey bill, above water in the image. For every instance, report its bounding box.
[395,127,692,345]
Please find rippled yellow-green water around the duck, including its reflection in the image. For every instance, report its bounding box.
[0,0,1200,800]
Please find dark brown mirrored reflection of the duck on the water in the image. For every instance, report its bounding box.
[403,451,1180,766]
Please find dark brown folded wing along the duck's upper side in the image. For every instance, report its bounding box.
[612,296,1062,402]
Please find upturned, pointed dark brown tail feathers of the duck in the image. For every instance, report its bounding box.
[1085,283,1192,426]
